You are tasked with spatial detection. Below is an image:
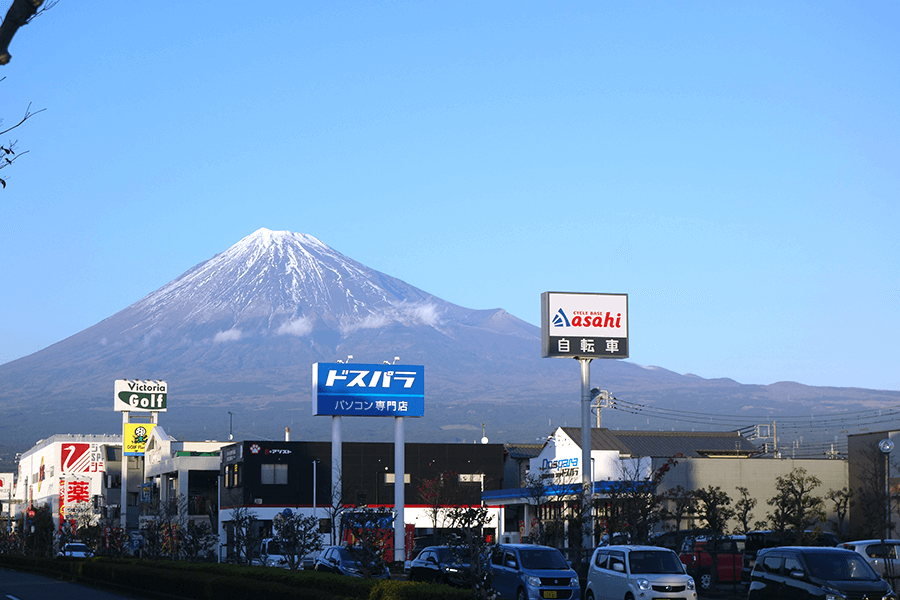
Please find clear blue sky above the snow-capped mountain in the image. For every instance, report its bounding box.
[0,0,900,390]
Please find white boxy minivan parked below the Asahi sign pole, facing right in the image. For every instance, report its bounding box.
[585,546,697,600]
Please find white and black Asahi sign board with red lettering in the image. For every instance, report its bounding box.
[541,292,628,358]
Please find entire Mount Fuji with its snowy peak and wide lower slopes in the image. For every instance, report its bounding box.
[0,229,900,456]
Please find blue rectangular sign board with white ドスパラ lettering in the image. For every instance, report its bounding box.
[313,363,425,417]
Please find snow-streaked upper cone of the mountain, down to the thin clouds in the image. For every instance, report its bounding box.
[116,228,452,341]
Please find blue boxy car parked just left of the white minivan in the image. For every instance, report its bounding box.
[491,544,581,600]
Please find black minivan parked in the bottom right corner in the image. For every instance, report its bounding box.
[750,546,897,600]
